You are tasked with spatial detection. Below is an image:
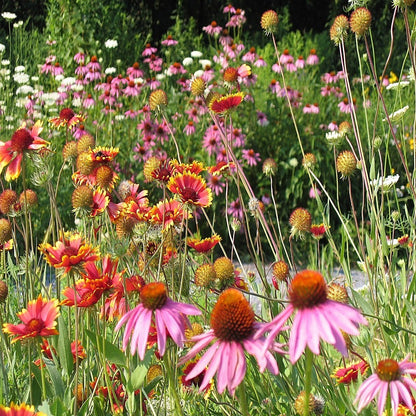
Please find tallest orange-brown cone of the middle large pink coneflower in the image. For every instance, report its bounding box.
[211,289,254,341]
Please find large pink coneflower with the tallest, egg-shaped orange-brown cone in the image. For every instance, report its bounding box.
[179,288,284,395]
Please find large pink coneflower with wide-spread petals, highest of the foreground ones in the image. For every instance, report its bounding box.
[256,270,367,364]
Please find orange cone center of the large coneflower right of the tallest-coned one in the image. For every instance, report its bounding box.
[289,270,327,309]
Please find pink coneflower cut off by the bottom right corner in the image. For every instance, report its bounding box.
[354,354,416,416]
